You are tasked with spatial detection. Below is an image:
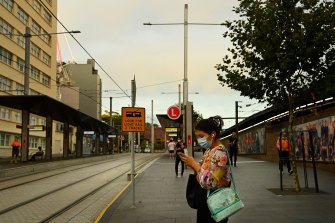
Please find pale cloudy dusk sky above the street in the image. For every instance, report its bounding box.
[58,0,264,128]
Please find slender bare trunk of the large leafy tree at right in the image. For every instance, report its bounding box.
[288,97,301,192]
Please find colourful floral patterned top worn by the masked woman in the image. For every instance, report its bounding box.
[198,145,231,189]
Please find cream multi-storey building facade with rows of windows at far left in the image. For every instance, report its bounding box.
[0,0,62,156]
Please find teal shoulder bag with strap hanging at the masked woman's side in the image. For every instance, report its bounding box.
[207,150,244,222]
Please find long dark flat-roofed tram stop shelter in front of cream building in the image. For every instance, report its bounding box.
[0,95,115,162]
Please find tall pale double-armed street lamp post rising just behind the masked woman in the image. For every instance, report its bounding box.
[143,4,224,157]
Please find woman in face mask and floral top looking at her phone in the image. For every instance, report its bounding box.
[179,116,231,223]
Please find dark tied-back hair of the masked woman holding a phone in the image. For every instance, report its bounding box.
[195,116,223,139]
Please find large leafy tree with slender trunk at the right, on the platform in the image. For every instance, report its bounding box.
[216,0,335,191]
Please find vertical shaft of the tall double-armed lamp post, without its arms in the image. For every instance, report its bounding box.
[183,4,188,143]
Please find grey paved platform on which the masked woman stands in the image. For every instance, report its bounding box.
[96,153,335,223]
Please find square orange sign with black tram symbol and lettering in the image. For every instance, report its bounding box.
[122,107,145,132]
